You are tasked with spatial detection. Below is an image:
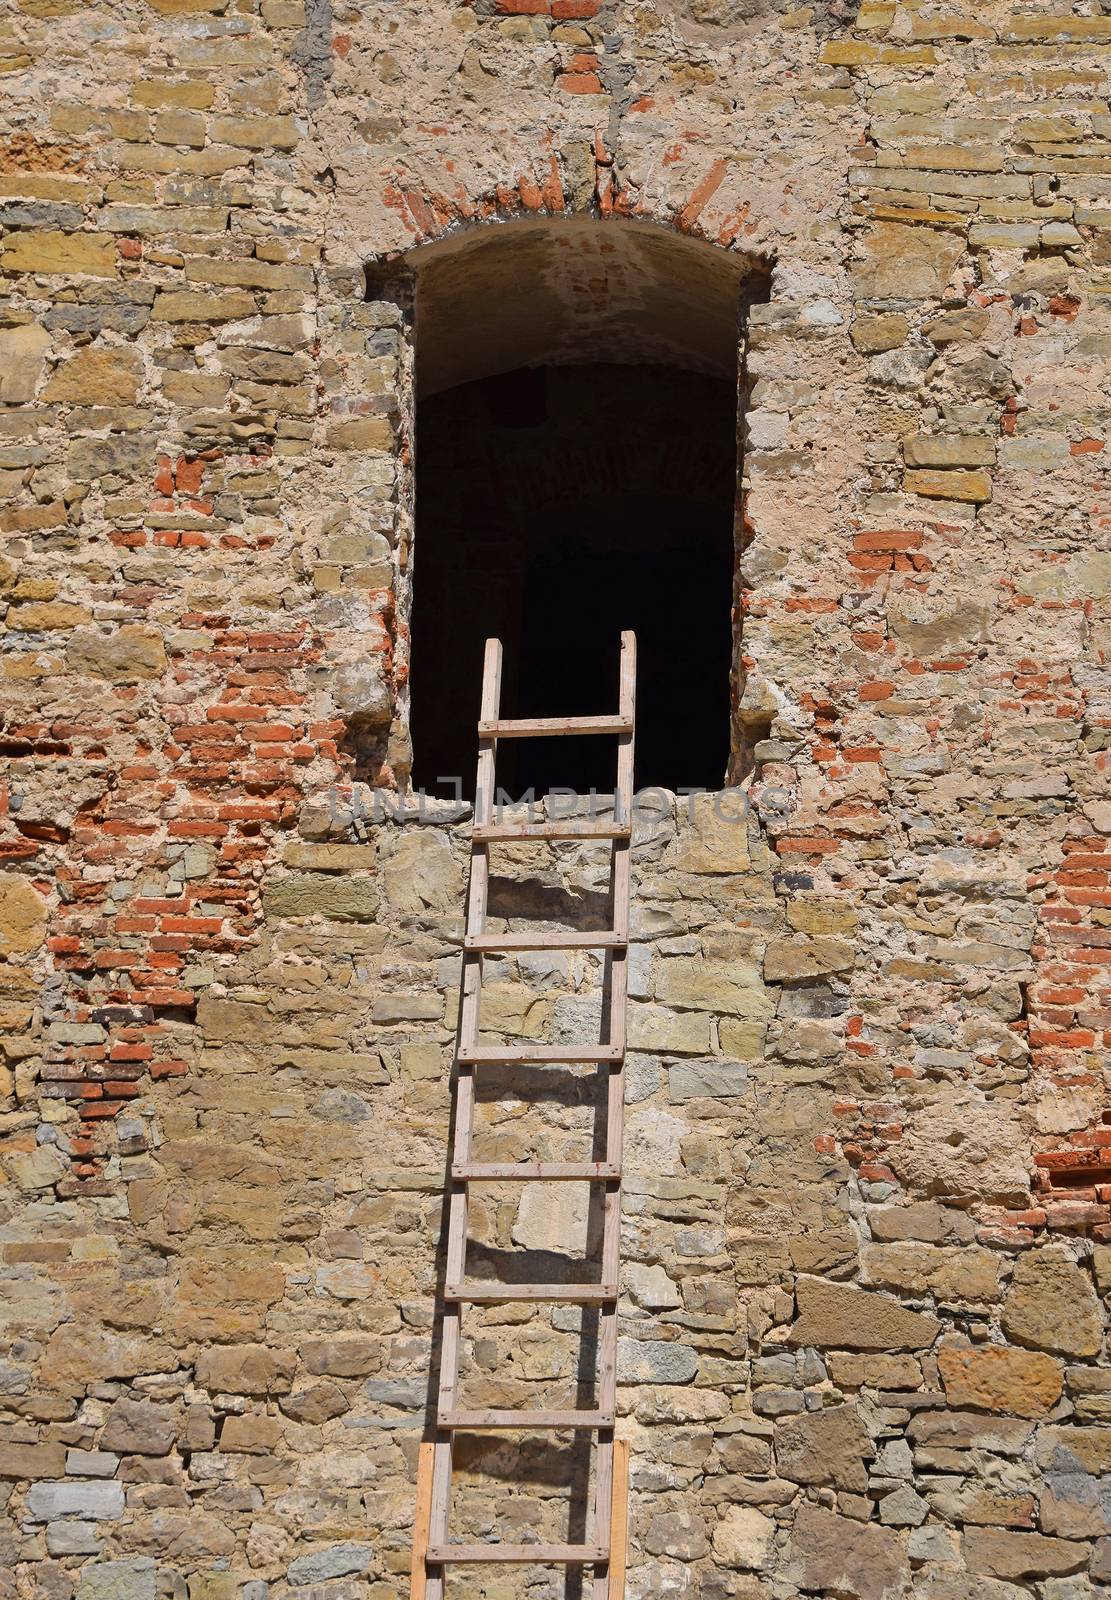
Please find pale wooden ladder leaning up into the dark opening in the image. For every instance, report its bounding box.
[410,632,637,1600]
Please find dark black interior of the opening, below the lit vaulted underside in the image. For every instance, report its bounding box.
[411,363,736,795]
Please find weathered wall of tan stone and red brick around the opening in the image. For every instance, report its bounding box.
[0,0,1111,1600]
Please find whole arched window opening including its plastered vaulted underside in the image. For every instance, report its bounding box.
[401,221,767,795]
